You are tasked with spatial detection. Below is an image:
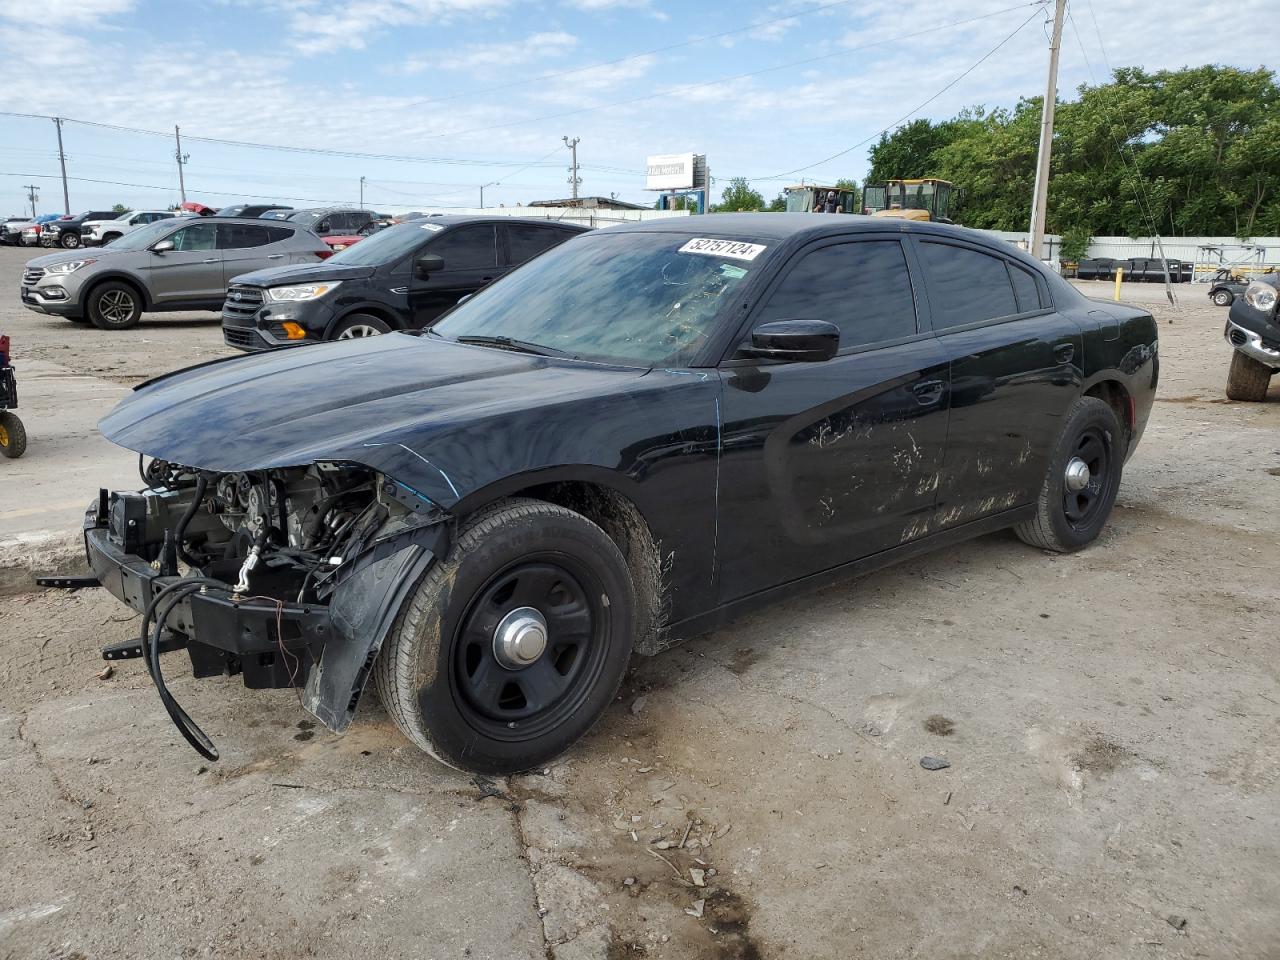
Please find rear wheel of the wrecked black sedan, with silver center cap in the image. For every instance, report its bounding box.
[1014,397,1128,553]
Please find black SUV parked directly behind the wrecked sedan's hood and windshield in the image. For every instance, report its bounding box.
[223,216,586,351]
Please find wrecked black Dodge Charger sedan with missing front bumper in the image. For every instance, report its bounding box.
[77,214,1158,773]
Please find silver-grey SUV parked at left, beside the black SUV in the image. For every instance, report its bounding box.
[20,216,330,330]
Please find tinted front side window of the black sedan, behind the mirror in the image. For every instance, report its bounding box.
[760,241,916,349]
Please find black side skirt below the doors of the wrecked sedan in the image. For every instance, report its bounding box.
[663,504,1036,649]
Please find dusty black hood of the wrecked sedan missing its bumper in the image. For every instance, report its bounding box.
[99,334,646,488]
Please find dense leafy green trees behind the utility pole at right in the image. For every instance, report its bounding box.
[868,65,1280,239]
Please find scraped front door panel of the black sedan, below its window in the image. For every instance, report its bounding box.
[718,338,950,603]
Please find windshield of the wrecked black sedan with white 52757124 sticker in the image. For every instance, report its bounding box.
[435,232,765,366]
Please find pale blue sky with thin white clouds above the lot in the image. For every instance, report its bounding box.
[0,0,1276,215]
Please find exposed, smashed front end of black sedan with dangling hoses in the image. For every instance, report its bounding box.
[84,461,451,759]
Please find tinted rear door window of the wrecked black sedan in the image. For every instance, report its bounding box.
[920,242,1019,330]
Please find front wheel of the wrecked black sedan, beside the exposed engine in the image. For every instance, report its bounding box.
[374,499,635,774]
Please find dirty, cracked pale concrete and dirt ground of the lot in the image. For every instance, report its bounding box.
[0,250,1280,960]
